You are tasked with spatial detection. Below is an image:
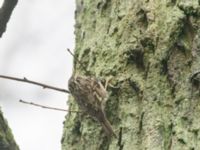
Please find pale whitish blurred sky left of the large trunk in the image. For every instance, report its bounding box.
[0,0,75,150]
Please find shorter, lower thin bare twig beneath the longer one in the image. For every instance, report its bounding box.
[19,99,81,113]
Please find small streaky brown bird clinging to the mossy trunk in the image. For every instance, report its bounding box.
[68,76,117,137]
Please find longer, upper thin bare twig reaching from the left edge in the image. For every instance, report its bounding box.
[0,75,70,93]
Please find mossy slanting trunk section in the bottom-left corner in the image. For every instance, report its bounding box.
[0,111,19,150]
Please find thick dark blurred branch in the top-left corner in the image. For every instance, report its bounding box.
[0,0,18,37]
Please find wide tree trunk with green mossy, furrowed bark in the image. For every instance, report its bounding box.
[62,0,200,150]
